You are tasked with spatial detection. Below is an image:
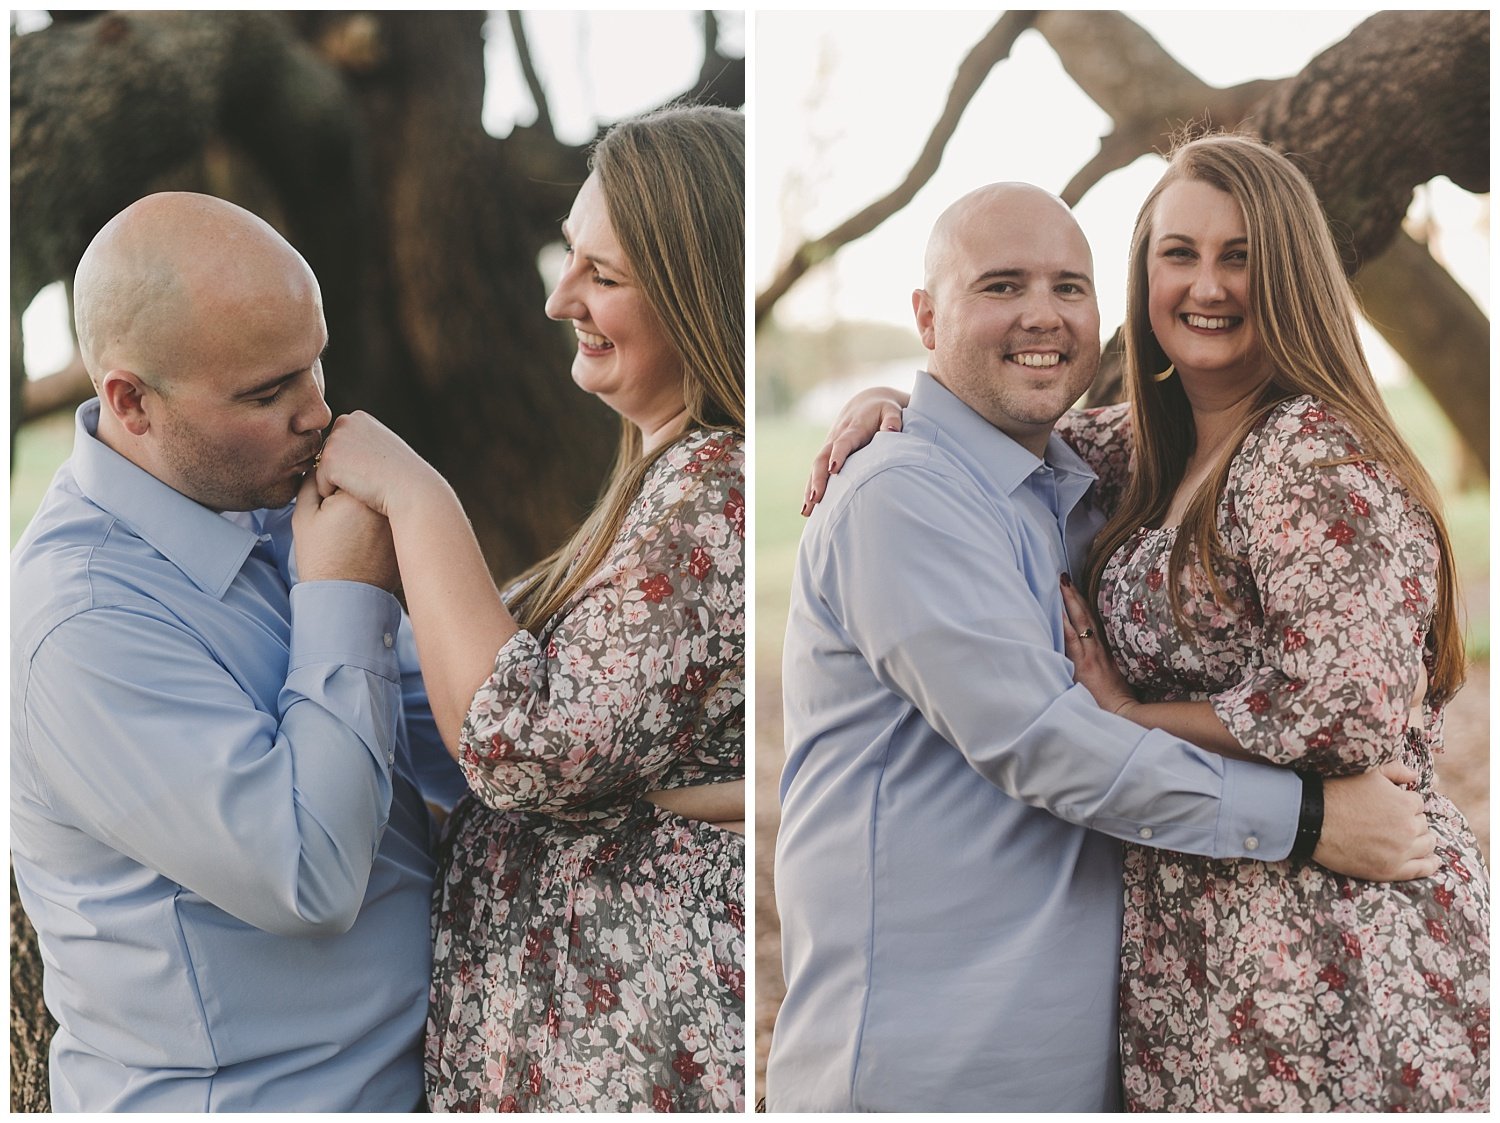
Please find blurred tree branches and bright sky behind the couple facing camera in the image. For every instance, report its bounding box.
[752,10,1490,1084]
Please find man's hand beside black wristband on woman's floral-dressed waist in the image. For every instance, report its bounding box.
[1313,762,1442,882]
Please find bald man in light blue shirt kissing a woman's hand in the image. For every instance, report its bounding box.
[11,193,461,1111]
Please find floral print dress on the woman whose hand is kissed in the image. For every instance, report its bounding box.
[426,432,746,1111]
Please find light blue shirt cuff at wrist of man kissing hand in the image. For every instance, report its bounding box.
[287,582,401,682]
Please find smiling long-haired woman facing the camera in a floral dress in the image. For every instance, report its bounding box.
[1065,136,1490,1111]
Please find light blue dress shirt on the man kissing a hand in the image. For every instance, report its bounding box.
[11,402,456,1111]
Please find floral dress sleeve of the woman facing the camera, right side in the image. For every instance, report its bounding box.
[1211,405,1437,775]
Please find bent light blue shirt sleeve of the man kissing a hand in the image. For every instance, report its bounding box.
[24,582,401,936]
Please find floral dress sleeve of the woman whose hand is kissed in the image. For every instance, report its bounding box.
[459,442,746,813]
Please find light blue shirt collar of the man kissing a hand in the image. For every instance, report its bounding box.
[72,397,260,597]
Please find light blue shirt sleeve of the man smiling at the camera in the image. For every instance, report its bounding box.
[815,468,1301,859]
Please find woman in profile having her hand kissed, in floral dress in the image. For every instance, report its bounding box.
[318,106,746,1111]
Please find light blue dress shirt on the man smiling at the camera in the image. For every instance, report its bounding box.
[767,373,1301,1111]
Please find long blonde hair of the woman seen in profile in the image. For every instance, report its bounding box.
[510,105,746,631]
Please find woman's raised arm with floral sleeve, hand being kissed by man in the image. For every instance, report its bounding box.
[318,414,744,820]
